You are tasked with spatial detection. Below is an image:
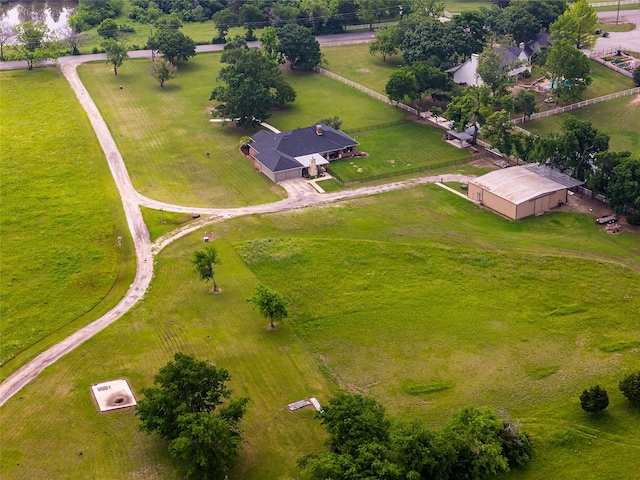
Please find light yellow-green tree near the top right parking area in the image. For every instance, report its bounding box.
[549,0,598,49]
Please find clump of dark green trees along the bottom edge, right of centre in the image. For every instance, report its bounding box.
[298,393,532,480]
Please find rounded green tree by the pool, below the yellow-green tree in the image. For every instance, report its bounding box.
[546,40,591,103]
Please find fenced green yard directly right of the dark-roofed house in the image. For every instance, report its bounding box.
[331,124,471,182]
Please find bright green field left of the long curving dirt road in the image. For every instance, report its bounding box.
[0,68,135,378]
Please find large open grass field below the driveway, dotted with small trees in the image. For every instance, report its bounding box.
[0,185,640,480]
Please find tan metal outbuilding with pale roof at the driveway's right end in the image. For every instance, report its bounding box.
[467,164,583,220]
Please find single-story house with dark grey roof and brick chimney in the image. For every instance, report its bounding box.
[249,123,358,182]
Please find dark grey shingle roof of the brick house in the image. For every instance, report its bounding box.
[251,123,358,172]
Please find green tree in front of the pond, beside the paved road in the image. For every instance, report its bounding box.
[8,22,58,70]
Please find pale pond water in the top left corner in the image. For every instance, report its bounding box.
[0,1,78,31]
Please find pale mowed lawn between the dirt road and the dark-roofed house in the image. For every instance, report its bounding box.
[78,54,282,207]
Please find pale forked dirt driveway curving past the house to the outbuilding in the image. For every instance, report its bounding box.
[0,57,471,406]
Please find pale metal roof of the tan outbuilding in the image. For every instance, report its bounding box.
[469,166,567,205]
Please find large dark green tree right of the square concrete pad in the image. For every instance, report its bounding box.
[136,353,248,480]
